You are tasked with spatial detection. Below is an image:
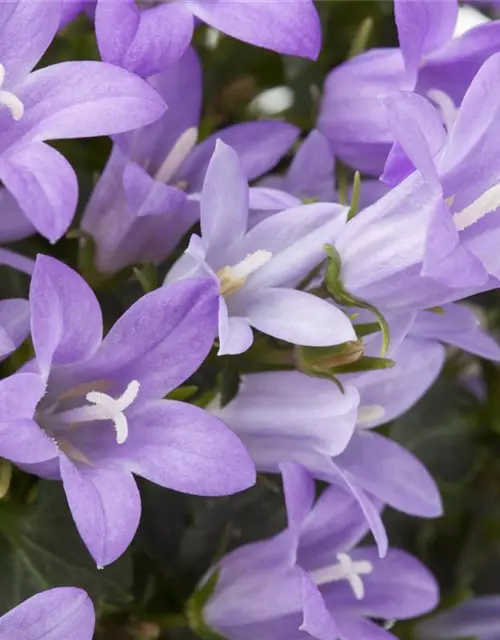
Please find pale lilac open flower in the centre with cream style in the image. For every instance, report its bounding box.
[166,140,355,354]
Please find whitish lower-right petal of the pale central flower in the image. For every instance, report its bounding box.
[238,288,356,347]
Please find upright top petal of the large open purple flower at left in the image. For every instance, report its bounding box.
[30,255,102,376]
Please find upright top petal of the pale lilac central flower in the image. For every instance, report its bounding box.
[200,141,248,248]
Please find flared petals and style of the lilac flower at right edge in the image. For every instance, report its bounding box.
[364,54,500,296]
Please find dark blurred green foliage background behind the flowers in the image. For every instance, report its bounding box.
[0,0,500,640]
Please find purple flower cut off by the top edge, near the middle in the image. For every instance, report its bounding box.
[96,0,321,76]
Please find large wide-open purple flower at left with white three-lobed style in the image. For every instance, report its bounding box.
[0,256,255,566]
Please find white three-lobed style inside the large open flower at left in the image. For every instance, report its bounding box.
[42,380,140,444]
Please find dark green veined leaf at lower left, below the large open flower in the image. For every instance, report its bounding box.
[0,481,132,613]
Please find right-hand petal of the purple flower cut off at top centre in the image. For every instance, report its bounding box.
[189,0,321,60]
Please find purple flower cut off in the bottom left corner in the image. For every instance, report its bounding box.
[0,587,95,640]
